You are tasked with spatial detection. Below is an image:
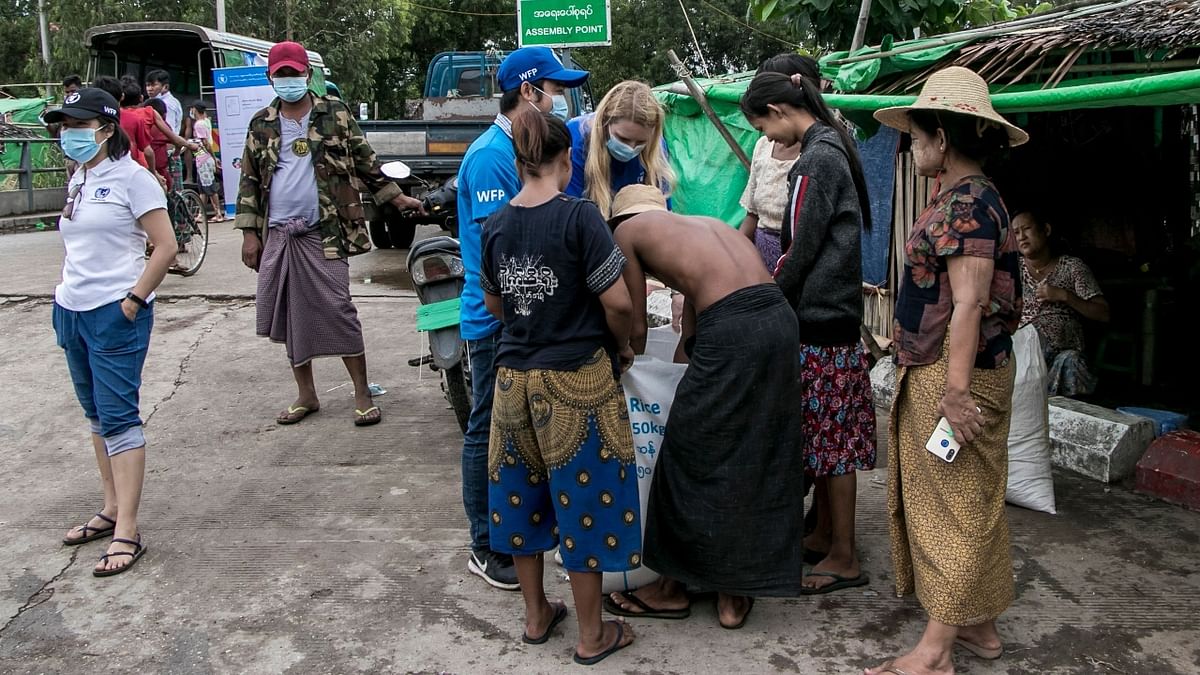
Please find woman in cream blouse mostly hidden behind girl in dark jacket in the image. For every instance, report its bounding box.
[739,53,821,273]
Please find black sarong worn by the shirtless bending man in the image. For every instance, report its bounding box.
[644,283,804,597]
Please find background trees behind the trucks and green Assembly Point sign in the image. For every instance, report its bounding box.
[0,0,806,117]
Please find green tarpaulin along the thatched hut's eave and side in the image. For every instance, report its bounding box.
[656,68,1200,226]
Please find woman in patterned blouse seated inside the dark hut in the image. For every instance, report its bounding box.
[1013,205,1109,396]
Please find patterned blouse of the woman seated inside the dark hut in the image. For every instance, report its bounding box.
[1021,256,1104,354]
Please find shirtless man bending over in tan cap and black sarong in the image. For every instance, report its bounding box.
[605,185,804,628]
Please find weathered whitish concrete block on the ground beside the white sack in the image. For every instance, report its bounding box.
[1050,396,1154,483]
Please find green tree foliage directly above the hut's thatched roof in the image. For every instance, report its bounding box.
[750,0,1050,52]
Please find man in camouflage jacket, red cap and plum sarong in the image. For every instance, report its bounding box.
[234,42,421,426]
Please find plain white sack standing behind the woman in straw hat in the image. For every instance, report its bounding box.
[1004,324,1056,514]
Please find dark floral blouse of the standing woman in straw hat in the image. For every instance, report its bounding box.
[893,175,1021,369]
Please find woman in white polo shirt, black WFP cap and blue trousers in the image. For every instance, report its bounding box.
[46,88,176,577]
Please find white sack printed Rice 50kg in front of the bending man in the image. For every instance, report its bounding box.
[602,353,688,593]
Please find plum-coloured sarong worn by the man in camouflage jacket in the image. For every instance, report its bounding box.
[256,221,365,368]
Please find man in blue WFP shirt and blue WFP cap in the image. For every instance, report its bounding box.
[458,47,588,591]
